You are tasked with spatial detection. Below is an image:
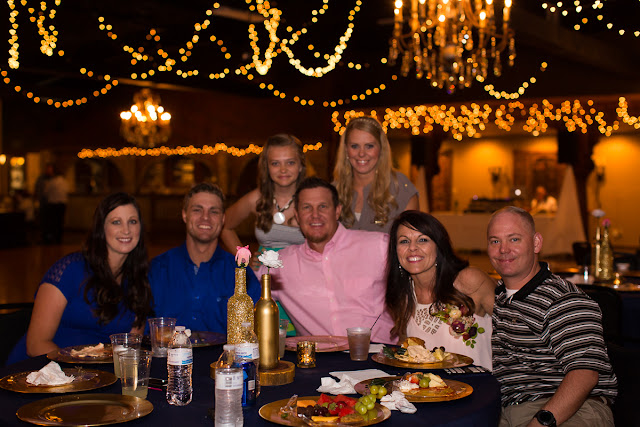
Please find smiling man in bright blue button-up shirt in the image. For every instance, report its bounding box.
[149,182,260,334]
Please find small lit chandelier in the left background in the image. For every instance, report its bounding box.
[120,89,171,148]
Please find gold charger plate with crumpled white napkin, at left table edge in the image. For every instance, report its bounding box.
[0,367,117,393]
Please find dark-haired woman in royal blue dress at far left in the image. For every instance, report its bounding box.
[9,193,152,363]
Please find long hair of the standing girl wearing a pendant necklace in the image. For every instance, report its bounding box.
[256,133,307,233]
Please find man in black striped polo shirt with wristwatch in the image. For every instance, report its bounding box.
[487,206,617,427]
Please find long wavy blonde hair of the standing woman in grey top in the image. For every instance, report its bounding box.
[333,116,398,228]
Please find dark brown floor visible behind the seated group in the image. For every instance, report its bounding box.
[0,232,574,304]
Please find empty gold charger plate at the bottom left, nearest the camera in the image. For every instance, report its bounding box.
[16,394,153,426]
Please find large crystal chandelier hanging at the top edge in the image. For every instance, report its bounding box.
[389,0,516,93]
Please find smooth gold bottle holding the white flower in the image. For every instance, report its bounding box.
[254,274,280,370]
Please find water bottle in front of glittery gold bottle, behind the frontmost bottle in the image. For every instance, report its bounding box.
[234,322,260,406]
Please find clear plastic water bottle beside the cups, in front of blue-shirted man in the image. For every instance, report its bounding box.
[167,326,193,406]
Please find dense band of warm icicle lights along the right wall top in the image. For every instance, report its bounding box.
[331,97,640,141]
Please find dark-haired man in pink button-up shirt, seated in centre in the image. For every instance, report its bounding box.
[258,177,397,344]
